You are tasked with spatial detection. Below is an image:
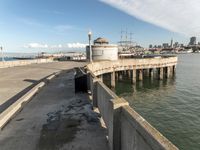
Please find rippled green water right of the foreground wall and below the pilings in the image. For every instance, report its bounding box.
[107,54,200,150]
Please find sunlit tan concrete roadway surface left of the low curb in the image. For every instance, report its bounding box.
[0,62,86,112]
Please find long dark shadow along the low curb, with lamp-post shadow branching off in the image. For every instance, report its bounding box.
[0,74,58,113]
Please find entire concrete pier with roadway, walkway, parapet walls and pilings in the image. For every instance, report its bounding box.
[0,57,178,150]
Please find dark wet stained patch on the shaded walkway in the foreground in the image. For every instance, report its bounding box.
[37,92,108,150]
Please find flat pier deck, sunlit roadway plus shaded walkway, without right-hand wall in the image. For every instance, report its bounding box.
[0,61,108,150]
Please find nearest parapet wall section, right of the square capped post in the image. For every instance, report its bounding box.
[121,106,178,150]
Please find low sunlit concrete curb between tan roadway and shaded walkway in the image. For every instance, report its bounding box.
[0,72,60,130]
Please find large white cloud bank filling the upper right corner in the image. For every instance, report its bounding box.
[100,0,200,36]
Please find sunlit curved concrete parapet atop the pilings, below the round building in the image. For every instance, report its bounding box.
[87,57,178,76]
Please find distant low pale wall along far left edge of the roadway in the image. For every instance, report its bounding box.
[0,59,53,68]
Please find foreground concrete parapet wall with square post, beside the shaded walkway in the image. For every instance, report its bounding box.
[89,74,178,150]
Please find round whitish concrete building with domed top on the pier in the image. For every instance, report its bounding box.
[86,38,118,61]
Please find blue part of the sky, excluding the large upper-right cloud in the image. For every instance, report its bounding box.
[0,0,195,52]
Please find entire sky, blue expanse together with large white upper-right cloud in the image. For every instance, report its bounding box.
[0,0,200,53]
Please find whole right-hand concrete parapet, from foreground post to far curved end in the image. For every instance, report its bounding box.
[87,57,178,150]
